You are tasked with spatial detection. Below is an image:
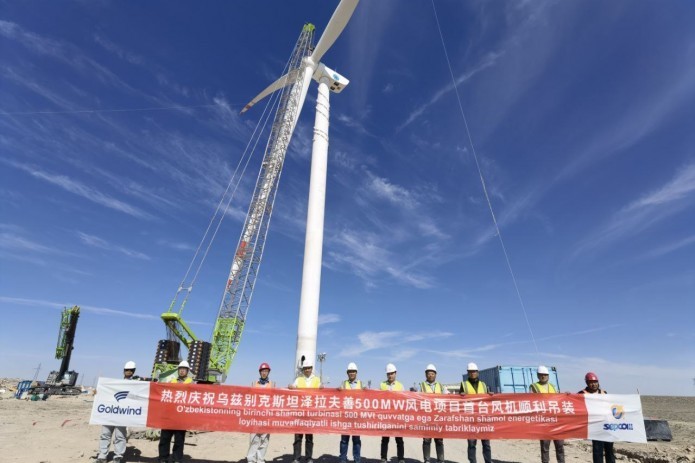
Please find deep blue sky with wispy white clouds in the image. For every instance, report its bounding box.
[0,0,695,395]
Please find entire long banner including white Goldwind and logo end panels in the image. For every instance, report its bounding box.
[90,379,646,442]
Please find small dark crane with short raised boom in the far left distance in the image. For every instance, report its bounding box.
[28,306,82,398]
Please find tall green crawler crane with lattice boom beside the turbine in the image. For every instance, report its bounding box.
[152,24,315,383]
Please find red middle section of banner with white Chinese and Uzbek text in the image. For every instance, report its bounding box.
[147,383,588,439]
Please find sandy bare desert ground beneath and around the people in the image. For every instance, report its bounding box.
[0,380,695,463]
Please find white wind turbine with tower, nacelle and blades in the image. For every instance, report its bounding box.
[241,0,359,376]
